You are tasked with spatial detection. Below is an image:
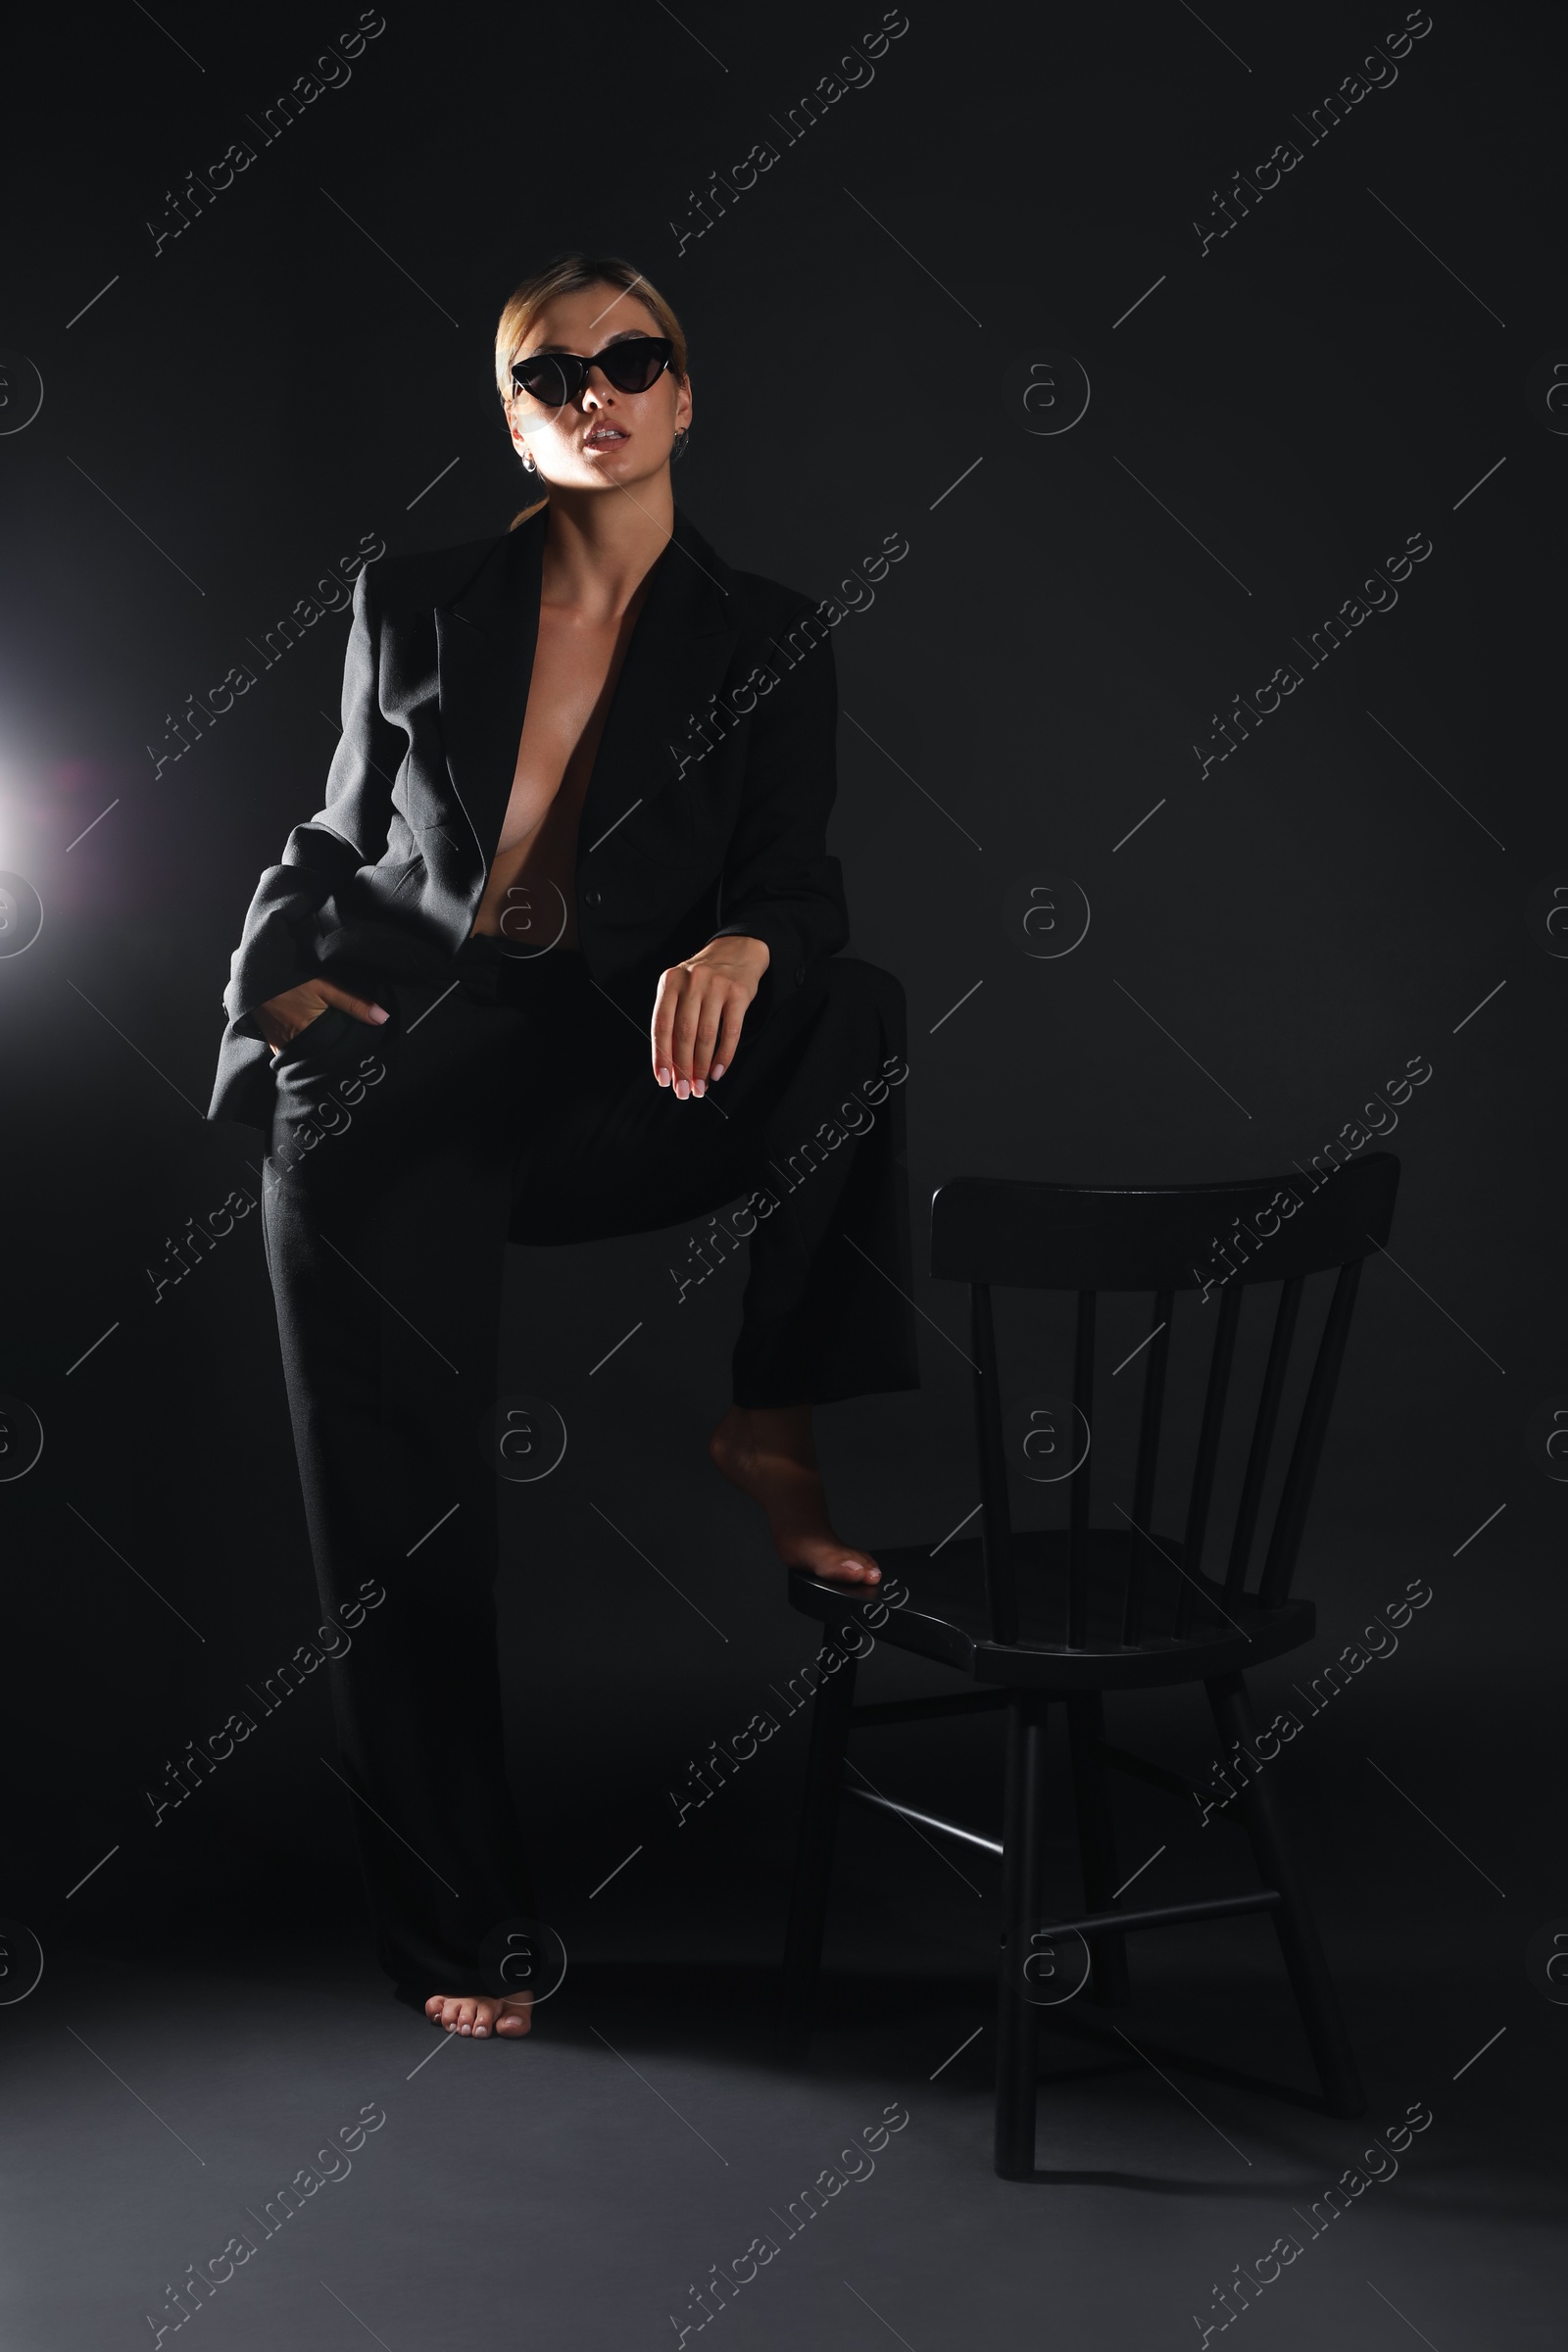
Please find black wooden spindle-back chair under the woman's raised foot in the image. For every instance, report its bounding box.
[785,1152,1398,2178]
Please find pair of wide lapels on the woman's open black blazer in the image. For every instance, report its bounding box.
[435,508,741,868]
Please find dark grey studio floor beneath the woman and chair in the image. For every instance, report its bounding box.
[0,1900,1566,2352]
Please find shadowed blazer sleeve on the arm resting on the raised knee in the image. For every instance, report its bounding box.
[712,607,849,1004]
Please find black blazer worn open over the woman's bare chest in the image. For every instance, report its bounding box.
[207,508,849,1129]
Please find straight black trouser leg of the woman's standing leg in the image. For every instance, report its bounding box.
[264,990,534,1997]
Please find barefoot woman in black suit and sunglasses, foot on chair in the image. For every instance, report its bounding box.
[209,254,919,2036]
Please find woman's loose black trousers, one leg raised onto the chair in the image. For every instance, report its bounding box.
[264,939,919,2004]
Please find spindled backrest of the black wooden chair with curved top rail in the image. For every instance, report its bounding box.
[931,1152,1398,1648]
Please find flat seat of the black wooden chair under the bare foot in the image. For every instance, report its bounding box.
[790,1529,1316,1695]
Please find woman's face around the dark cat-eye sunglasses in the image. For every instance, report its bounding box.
[508,284,691,489]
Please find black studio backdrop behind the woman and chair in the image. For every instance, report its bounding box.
[0,0,1568,2248]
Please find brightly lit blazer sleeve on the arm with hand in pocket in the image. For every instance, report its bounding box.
[223,564,407,1037]
